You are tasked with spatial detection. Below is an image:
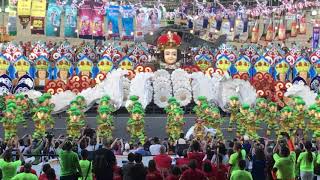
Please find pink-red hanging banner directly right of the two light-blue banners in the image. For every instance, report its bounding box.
[79,0,92,39]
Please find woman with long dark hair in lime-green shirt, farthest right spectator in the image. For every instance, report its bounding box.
[297,141,316,180]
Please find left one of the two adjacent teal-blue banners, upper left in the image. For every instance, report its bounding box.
[46,2,62,36]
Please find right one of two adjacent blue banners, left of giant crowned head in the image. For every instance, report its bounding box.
[121,5,135,39]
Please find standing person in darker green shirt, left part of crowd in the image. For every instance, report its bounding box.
[58,140,82,180]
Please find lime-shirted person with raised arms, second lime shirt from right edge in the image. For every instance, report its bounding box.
[273,146,296,180]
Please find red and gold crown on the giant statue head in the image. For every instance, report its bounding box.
[157,31,181,49]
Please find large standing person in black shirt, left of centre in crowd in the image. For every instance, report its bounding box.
[92,139,116,180]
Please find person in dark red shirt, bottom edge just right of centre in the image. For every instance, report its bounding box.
[180,159,207,180]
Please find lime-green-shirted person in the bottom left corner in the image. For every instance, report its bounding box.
[0,149,22,180]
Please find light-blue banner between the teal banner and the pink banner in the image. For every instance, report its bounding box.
[64,5,78,37]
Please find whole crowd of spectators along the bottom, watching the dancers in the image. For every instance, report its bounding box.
[0,127,320,180]
